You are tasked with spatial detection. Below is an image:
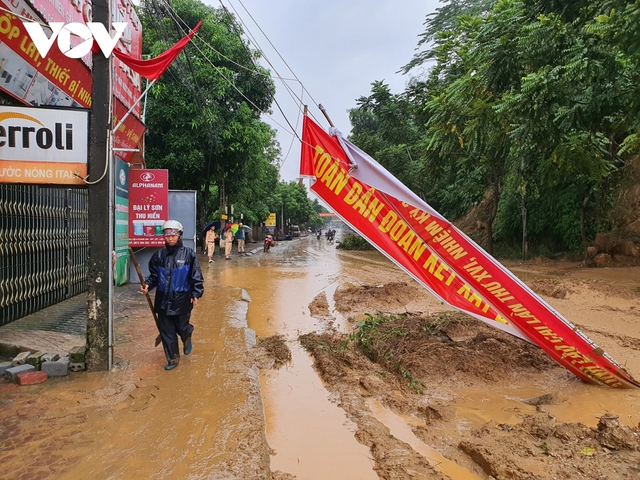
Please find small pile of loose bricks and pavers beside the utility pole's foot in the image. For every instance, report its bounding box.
[0,346,86,385]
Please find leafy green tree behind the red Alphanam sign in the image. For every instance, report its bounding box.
[140,0,279,227]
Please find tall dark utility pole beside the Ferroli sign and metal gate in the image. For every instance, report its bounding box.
[85,0,113,371]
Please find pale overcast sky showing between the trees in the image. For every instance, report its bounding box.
[212,0,440,181]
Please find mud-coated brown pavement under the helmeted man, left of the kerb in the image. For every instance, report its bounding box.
[0,272,268,479]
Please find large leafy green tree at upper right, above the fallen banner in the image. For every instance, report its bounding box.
[405,0,640,255]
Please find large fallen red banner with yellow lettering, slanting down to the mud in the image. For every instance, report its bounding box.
[300,117,640,387]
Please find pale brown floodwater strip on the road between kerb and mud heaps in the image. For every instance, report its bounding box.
[219,237,378,479]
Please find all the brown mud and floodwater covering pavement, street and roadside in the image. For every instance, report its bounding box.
[0,235,640,480]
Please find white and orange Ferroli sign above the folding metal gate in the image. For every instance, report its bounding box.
[0,106,89,185]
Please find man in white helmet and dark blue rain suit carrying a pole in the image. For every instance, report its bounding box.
[140,220,204,370]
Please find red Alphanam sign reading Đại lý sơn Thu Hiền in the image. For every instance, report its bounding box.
[129,169,169,247]
